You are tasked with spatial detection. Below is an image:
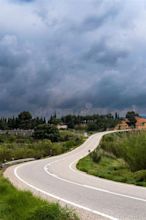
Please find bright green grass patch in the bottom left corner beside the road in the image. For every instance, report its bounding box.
[0,173,79,220]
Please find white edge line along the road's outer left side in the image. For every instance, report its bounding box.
[14,164,118,220]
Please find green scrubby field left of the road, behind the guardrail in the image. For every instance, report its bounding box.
[0,131,84,163]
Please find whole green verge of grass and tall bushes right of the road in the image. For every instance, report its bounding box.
[77,131,146,186]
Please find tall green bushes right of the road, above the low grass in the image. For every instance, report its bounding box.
[101,131,146,171]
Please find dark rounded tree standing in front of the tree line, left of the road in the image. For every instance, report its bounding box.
[33,124,60,142]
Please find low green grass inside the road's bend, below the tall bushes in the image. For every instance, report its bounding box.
[77,155,146,186]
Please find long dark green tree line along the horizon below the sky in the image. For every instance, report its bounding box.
[0,111,120,131]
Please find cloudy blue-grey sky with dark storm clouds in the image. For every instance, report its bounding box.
[0,0,146,115]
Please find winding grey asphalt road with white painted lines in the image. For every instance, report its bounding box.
[5,132,146,220]
